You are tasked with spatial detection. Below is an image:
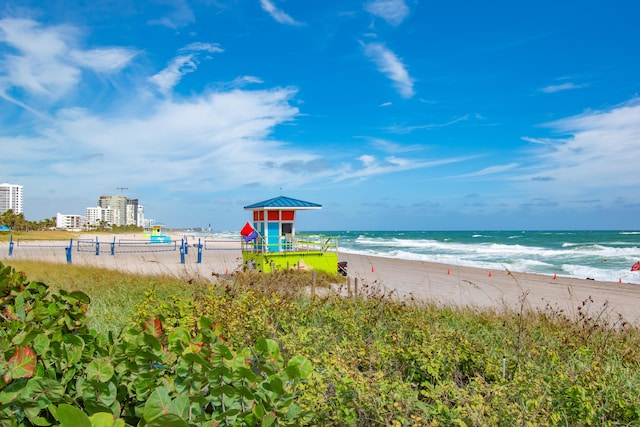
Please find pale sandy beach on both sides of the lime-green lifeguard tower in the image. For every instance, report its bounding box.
[0,235,640,324]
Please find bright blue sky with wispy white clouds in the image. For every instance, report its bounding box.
[0,0,640,230]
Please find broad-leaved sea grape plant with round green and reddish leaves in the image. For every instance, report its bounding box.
[0,263,312,427]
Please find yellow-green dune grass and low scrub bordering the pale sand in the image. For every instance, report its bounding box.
[5,262,640,426]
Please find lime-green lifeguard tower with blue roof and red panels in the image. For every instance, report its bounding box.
[241,196,338,274]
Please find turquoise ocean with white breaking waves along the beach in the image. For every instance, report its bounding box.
[182,230,640,284]
